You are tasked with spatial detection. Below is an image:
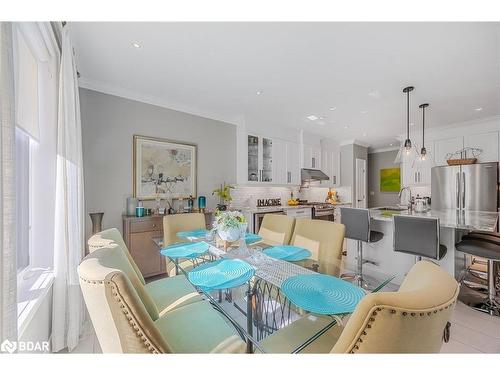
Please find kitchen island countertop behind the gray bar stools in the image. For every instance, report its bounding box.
[370,208,498,232]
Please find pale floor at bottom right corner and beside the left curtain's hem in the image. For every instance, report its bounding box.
[72,302,500,353]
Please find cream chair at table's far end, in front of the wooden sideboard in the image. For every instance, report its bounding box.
[163,213,206,276]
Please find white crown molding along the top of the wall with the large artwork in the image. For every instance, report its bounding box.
[78,77,240,125]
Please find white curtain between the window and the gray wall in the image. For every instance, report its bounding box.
[52,25,85,351]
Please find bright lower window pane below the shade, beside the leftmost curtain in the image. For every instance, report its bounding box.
[15,127,31,272]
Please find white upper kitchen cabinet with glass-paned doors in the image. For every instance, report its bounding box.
[247,134,274,183]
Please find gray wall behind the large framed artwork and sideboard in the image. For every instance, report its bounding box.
[80,89,236,234]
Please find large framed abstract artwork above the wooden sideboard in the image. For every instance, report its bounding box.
[133,135,197,199]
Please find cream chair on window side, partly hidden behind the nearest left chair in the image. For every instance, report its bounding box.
[88,228,202,316]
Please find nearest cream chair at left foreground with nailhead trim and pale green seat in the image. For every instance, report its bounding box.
[78,243,246,353]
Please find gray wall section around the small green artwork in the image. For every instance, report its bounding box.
[368,150,400,207]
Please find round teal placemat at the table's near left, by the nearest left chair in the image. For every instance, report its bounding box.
[188,259,255,289]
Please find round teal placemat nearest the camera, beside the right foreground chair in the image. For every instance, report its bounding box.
[281,274,365,315]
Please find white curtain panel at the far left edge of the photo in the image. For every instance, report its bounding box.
[0,22,17,342]
